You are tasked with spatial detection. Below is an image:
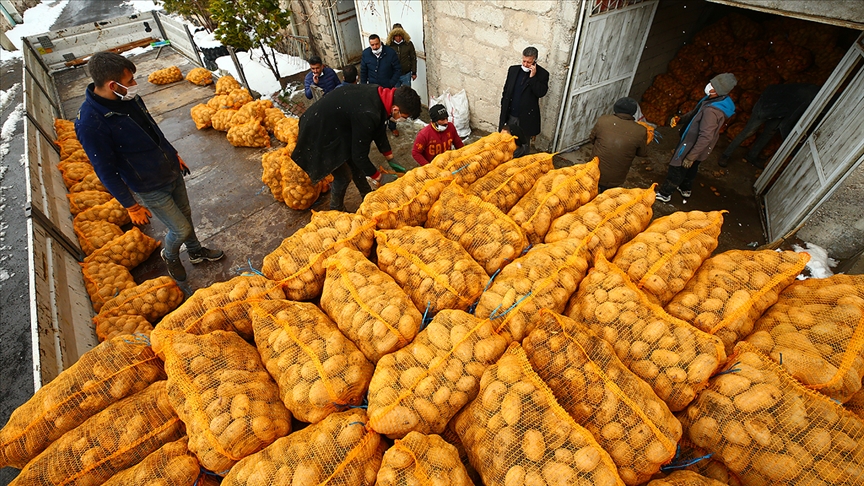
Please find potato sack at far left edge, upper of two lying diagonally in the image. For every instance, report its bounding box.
[0,336,165,469]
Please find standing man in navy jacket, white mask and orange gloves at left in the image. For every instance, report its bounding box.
[75,52,224,281]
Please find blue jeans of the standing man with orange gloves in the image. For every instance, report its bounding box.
[137,175,201,260]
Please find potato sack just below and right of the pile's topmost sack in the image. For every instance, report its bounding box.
[468,153,554,213]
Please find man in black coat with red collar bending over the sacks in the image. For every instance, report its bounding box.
[291,84,420,211]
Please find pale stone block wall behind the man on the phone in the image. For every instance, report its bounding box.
[423,0,580,150]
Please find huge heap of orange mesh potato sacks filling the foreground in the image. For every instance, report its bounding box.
[0,124,864,486]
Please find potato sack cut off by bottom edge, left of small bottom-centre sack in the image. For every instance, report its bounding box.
[222,409,384,486]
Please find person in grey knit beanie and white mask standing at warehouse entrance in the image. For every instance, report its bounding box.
[657,73,738,202]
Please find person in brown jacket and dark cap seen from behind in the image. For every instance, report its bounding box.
[589,98,648,192]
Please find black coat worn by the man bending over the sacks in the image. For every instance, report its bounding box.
[291,84,394,182]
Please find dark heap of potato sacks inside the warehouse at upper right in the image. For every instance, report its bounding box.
[639,13,857,157]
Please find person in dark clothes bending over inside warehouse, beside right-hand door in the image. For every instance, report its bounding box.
[717,84,820,169]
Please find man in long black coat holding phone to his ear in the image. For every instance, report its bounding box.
[498,47,549,157]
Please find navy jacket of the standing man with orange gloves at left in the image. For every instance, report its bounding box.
[75,83,180,208]
